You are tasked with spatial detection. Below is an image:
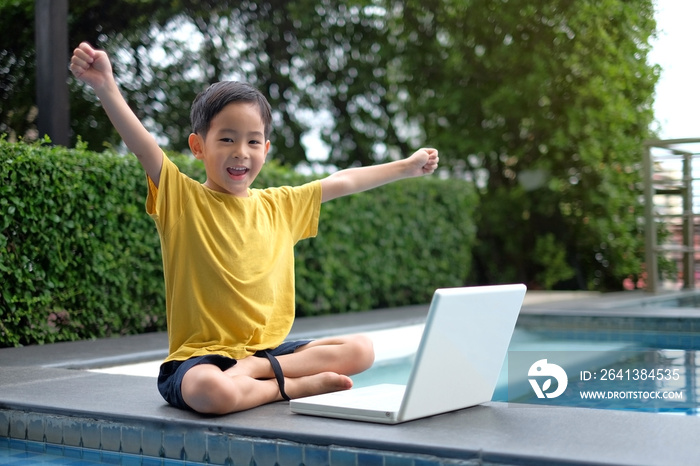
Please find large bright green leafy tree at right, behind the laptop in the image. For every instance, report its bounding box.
[386,0,657,289]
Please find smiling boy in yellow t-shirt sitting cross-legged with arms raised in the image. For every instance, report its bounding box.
[70,43,438,414]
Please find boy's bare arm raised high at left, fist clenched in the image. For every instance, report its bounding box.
[70,42,163,186]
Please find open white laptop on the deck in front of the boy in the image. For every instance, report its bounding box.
[290,284,526,424]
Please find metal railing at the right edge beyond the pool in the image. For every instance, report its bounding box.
[644,138,700,292]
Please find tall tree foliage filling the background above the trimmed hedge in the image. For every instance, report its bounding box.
[0,0,658,289]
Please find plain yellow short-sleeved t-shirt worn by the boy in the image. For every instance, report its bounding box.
[146,155,321,361]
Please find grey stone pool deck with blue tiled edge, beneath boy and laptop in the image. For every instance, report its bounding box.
[0,292,700,466]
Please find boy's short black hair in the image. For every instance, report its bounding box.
[190,81,272,140]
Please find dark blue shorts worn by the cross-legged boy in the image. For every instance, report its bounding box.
[158,340,313,411]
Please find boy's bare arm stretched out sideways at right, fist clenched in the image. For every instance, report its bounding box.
[321,149,440,202]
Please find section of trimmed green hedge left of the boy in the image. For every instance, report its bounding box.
[0,141,164,346]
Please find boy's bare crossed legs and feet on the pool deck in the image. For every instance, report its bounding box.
[181,335,374,414]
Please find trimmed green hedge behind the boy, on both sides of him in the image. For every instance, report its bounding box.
[0,139,477,347]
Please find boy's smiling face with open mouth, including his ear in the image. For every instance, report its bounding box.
[189,102,270,197]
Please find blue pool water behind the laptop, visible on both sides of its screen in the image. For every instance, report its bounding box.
[352,329,700,415]
